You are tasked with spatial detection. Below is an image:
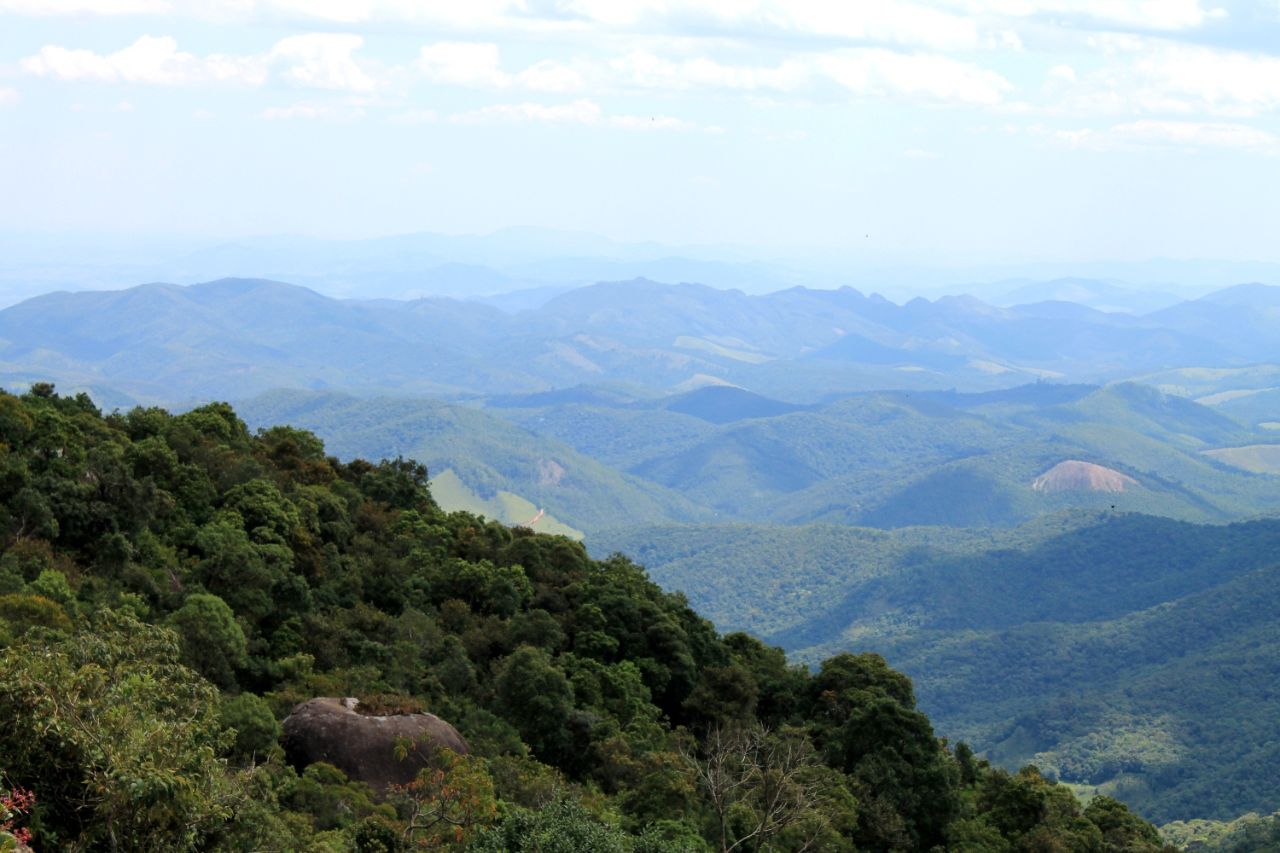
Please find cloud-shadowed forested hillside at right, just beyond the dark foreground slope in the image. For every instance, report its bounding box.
[593,511,1280,821]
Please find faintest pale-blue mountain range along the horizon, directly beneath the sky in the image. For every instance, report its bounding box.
[0,227,1280,307]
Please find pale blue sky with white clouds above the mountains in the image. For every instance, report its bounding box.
[0,0,1280,263]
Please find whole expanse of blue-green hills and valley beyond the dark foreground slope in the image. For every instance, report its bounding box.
[0,280,1280,822]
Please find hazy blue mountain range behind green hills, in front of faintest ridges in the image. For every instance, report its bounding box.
[0,272,1280,405]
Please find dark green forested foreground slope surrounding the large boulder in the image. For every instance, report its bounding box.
[0,384,1162,853]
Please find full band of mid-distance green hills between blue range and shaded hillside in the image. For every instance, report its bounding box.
[237,383,1280,538]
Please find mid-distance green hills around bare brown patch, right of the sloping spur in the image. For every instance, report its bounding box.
[493,383,1280,528]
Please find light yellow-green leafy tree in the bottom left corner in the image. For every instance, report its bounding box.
[0,611,257,850]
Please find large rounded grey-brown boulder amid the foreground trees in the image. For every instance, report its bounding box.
[284,698,471,792]
